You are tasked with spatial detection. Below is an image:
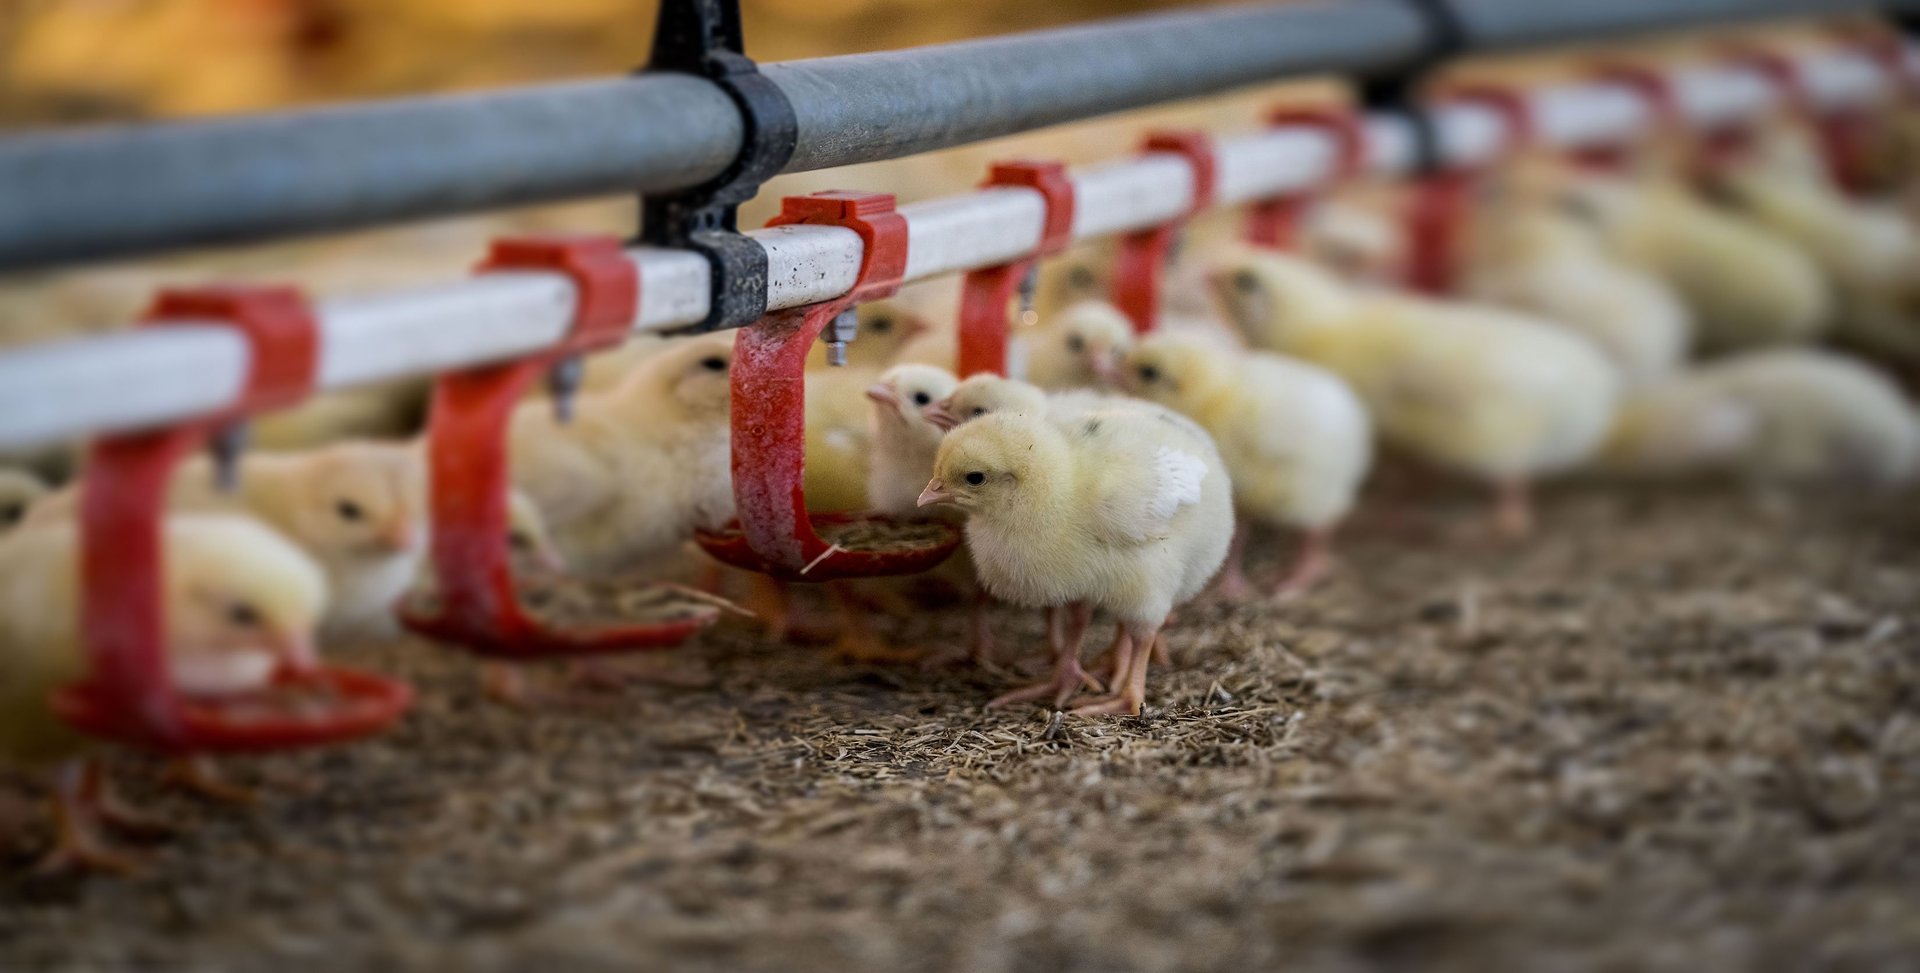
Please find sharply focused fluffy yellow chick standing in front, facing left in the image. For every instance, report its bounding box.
[920,405,1233,714]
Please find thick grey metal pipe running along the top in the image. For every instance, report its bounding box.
[0,0,1916,269]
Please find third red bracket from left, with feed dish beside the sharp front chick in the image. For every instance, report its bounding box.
[697,192,960,581]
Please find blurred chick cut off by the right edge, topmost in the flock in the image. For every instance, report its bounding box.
[1715,131,1920,359]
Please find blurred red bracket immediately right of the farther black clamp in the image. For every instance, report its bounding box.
[1405,84,1536,294]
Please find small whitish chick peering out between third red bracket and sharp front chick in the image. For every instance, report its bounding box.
[866,365,960,516]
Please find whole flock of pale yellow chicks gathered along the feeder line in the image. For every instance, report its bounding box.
[0,83,1920,864]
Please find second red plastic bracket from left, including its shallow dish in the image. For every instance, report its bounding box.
[399,236,718,660]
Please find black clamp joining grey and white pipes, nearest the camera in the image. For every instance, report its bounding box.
[639,0,799,332]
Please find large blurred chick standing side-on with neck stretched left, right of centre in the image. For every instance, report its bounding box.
[1215,251,1619,535]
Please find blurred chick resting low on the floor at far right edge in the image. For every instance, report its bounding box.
[1599,347,1920,484]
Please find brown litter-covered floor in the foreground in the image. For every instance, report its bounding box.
[0,487,1920,971]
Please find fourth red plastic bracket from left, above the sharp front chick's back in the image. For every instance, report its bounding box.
[958,161,1073,378]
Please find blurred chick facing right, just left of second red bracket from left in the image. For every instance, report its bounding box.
[29,441,426,639]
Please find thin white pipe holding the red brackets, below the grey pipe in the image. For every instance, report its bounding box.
[0,54,1887,449]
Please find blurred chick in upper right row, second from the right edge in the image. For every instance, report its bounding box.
[1563,177,1834,351]
